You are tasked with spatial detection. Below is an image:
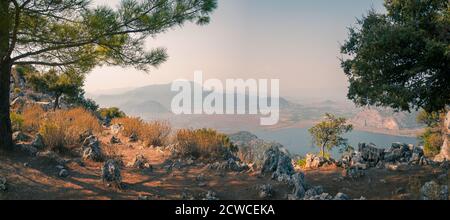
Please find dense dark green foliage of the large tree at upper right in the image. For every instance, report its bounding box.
[341,0,450,112]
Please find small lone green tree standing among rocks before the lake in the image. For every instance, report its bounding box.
[308,113,353,157]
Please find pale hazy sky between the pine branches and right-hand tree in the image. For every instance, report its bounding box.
[85,0,383,98]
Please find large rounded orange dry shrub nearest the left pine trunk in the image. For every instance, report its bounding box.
[39,108,101,151]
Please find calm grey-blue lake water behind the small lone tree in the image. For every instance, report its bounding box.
[253,128,418,158]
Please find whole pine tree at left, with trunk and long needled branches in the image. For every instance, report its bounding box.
[0,0,217,148]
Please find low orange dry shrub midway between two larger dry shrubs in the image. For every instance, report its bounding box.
[112,117,172,147]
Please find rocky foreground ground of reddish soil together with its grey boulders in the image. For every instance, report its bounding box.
[0,130,449,200]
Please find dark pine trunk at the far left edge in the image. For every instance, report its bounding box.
[0,62,13,149]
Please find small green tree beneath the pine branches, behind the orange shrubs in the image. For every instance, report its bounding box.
[27,69,84,110]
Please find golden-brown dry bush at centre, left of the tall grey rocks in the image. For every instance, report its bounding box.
[175,129,238,160]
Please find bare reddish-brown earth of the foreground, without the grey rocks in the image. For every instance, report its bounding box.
[0,131,448,200]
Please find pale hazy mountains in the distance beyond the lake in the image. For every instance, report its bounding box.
[93,84,426,131]
